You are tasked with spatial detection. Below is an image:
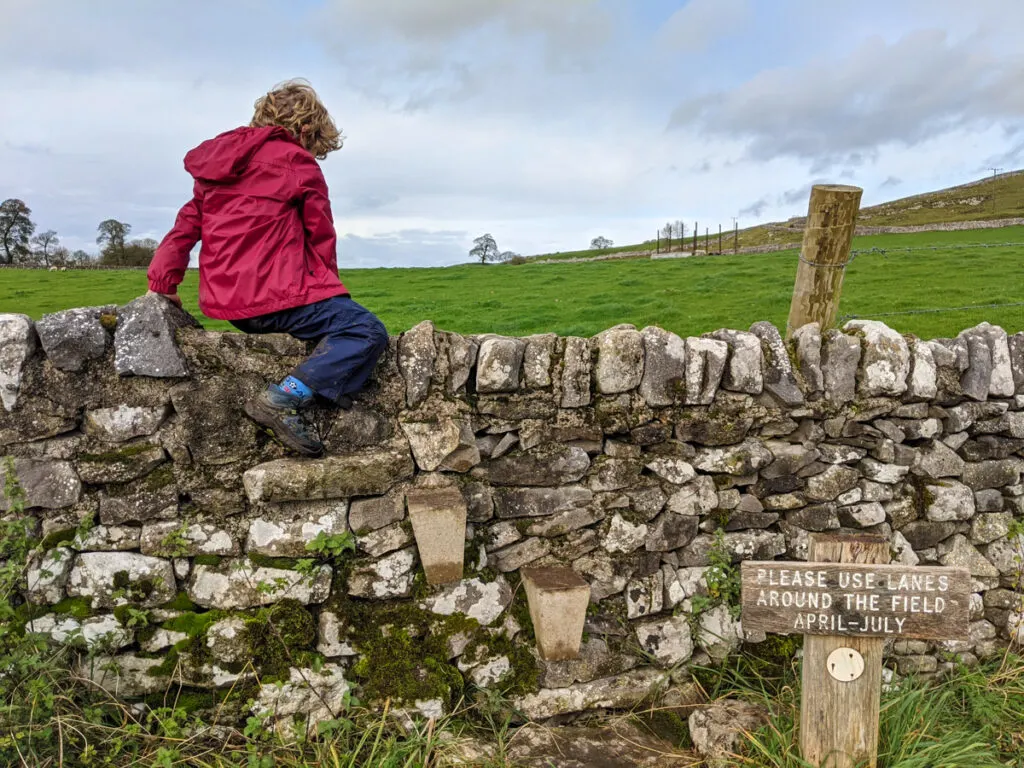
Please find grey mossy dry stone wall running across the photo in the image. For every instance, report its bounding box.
[0,297,1024,722]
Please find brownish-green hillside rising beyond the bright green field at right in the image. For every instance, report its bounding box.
[534,170,1024,259]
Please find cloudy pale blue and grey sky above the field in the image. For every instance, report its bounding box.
[0,0,1024,272]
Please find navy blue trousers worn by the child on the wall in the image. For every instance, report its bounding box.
[231,296,387,402]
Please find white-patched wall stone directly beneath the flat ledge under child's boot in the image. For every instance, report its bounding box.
[245,499,348,557]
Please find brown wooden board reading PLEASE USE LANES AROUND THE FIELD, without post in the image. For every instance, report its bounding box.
[740,561,971,640]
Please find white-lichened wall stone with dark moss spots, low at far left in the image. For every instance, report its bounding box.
[68,552,177,608]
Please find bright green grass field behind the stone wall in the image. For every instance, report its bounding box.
[0,226,1024,338]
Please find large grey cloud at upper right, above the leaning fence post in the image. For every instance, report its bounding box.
[671,30,1024,167]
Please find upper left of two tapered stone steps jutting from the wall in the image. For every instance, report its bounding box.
[406,488,466,584]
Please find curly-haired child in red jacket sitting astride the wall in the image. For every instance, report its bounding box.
[148,81,387,456]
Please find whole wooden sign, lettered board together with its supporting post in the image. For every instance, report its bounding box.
[740,534,971,768]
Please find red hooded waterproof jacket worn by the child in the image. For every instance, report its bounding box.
[148,127,348,319]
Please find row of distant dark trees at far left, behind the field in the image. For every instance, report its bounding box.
[0,198,159,267]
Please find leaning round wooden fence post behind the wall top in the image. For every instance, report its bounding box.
[785,184,864,338]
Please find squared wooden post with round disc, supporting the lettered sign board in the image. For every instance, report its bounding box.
[800,536,889,768]
